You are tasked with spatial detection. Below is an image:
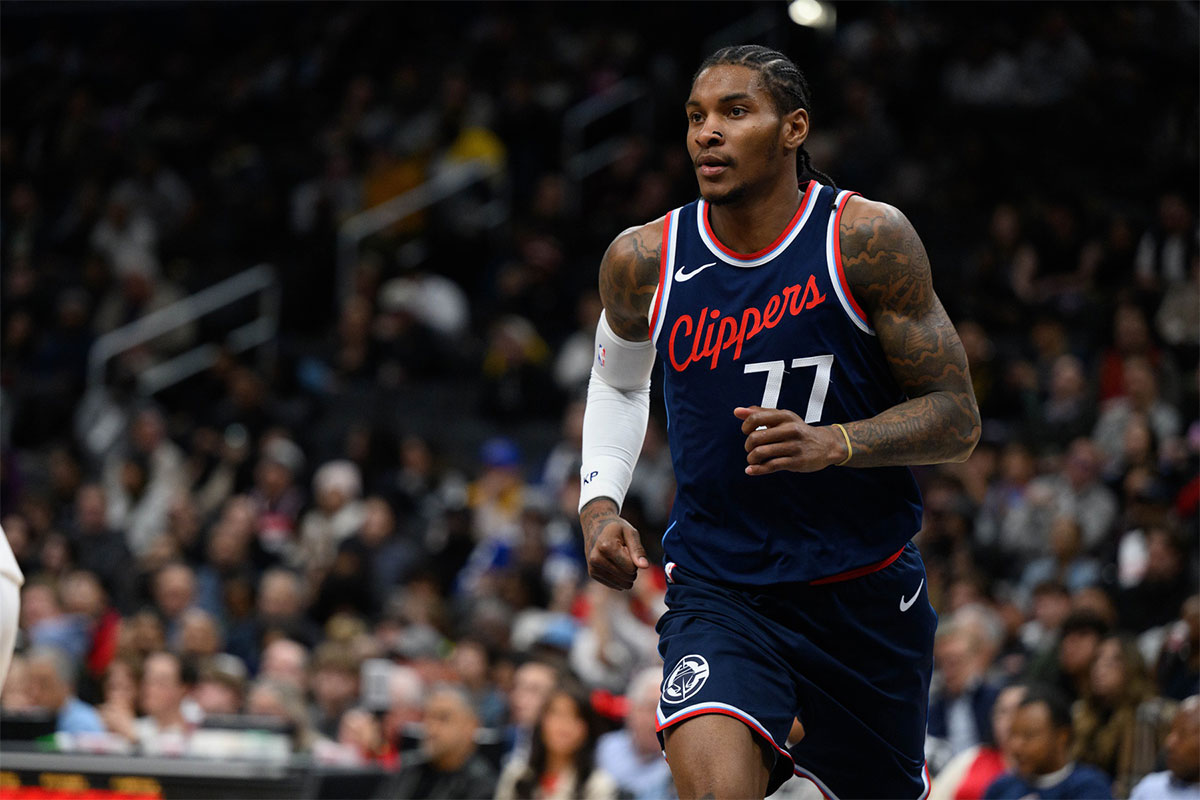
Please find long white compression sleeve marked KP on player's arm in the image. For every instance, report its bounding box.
[580,313,654,511]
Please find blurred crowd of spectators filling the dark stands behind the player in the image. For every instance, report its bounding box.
[0,4,1200,799]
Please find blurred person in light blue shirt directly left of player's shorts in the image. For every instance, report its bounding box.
[596,667,674,800]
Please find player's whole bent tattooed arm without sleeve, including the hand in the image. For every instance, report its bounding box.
[733,197,979,475]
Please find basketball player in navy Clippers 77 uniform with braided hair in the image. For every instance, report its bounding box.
[581,46,979,799]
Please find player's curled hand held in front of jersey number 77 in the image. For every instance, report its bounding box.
[733,405,846,475]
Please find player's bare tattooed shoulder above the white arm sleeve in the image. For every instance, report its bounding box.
[600,219,664,342]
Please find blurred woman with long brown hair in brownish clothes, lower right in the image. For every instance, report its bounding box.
[1073,636,1158,796]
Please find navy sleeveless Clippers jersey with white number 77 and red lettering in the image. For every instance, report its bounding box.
[650,181,920,585]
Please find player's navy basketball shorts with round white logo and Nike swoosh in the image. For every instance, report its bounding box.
[658,542,937,800]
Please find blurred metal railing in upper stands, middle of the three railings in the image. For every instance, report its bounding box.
[337,158,508,303]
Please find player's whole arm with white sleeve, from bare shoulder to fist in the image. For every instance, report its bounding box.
[580,219,664,589]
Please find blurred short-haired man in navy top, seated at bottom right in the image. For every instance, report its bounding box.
[984,686,1112,800]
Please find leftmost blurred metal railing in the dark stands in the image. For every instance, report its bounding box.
[88,264,280,396]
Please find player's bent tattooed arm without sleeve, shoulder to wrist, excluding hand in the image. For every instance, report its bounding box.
[839,197,980,467]
